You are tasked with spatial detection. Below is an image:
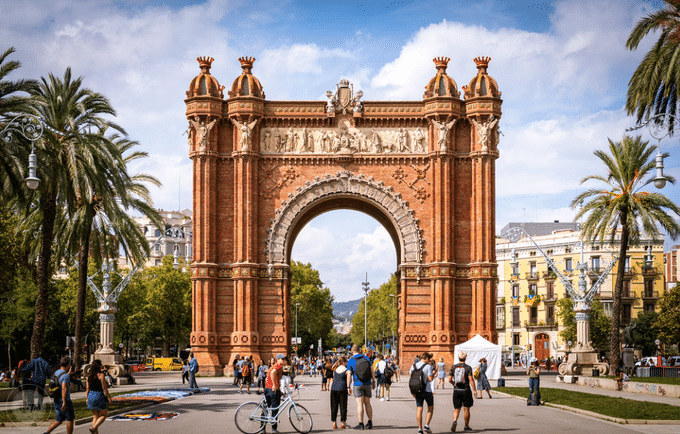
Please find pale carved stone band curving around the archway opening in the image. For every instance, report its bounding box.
[265,171,424,271]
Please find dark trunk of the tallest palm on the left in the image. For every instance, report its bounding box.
[31,191,57,359]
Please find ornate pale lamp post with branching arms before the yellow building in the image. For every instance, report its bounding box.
[501,226,618,376]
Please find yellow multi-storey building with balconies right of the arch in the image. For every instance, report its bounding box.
[496,222,664,360]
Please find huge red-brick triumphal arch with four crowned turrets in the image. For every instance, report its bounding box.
[185,57,502,374]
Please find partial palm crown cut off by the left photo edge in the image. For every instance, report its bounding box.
[0,47,38,202]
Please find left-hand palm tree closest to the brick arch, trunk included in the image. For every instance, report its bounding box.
[53,131,163,368]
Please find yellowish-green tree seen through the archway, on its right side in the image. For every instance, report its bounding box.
[351,274,397,350]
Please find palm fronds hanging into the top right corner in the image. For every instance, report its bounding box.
[626,0,680,131]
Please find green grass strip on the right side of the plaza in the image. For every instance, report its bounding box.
[494,387,680,420]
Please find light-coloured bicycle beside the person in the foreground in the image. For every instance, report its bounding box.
[234,384,312,434]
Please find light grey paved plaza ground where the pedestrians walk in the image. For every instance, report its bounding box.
[0,372,680,434]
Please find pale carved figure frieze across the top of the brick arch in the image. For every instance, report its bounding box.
[260,125,428,154]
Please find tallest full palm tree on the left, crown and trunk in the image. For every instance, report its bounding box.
[24,68,124,358]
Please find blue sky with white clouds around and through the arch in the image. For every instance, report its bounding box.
[0,0,680,301]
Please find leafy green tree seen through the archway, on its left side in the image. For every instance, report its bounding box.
[290,261,333,356]
